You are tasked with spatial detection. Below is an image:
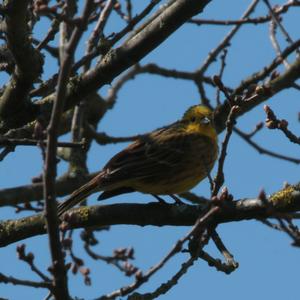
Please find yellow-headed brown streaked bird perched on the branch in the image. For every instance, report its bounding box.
[57,105,218,217]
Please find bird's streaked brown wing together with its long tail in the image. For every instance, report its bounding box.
[58,129,184,216]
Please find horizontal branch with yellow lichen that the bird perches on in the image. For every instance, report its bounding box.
[0,184,300,247]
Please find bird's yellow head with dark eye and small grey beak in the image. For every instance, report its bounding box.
[182,105,217,140]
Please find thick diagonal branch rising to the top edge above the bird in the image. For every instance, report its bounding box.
[19,0,210,129]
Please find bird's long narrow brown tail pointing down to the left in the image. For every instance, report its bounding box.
[57,174,100,217]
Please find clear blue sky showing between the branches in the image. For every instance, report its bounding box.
[0,0,300,300]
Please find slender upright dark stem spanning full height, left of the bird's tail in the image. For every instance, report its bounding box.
[44,0,94,299]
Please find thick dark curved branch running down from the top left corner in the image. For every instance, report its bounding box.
[0,0,43,128]
